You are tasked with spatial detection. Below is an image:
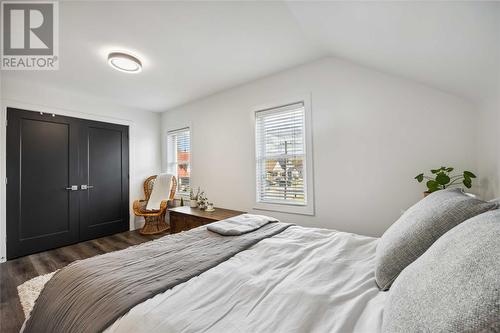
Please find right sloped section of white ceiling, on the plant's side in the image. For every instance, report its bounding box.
[288,1,500,100]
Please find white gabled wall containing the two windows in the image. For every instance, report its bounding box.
[162,58,478,236]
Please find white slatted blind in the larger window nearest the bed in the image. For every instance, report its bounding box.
[255,103,307,206]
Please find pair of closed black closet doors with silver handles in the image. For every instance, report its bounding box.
[7,108,130,259]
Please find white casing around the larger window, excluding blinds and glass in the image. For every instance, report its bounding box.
[252,94,315,215]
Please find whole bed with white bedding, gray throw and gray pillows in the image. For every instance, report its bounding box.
[23,190,500,333]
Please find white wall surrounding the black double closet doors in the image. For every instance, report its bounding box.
[0,80,161,258]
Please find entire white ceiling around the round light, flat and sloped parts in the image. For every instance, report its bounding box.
[2,1,500,111]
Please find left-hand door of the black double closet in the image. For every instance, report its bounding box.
[7,108,79,259]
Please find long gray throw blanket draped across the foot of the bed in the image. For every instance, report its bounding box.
[24,223,290,333]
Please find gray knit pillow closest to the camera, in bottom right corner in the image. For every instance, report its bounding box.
[382,210,500,333]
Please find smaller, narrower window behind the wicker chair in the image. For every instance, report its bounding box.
[167,127,191,195]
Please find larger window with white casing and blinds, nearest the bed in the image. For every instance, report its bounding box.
[255,98,314,215]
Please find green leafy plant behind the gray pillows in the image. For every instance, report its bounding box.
[415,167,476,197]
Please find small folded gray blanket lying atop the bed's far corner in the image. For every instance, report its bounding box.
[207,214,279,236]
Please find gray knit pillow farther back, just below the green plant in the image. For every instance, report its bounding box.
[375,189,497,290]
